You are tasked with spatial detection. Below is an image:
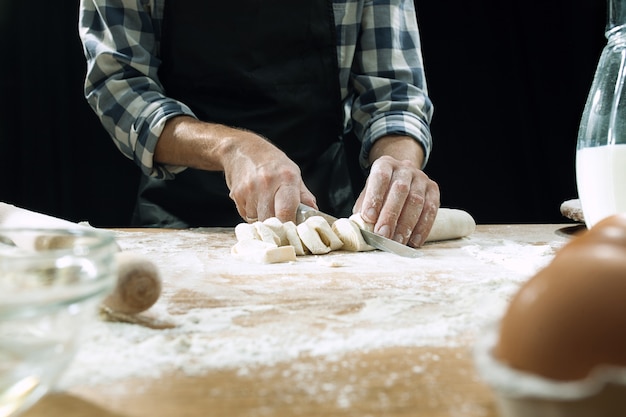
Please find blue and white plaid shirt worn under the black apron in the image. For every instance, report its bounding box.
[79,0,433,178]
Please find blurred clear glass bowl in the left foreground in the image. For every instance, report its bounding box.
[0,227,118,417]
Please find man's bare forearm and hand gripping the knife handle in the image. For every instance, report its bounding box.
[154,116,317,222]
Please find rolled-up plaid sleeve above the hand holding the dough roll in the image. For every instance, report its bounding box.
[342,0,433,169]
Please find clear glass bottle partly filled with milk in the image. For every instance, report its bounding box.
[576,0,626,228]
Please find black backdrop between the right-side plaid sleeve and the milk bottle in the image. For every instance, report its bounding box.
[416,0,606,223]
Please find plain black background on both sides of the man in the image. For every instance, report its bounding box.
[0,0,606,227]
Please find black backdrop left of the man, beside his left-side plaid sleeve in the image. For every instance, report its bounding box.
[0,0,139,226]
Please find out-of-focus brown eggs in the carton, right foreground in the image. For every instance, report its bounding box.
[494,215,626,380]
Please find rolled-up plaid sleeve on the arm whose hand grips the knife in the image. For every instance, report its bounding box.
[79,0,194,178]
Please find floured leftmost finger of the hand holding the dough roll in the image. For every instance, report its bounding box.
[360,158,393,224]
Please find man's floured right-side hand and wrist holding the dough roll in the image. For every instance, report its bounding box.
[354,136,439,247]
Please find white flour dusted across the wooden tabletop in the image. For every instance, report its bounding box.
[54,230,554,390]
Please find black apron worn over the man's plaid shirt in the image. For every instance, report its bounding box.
[134,0,356,228]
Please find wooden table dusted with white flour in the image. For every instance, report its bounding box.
[24,224,579,417]
